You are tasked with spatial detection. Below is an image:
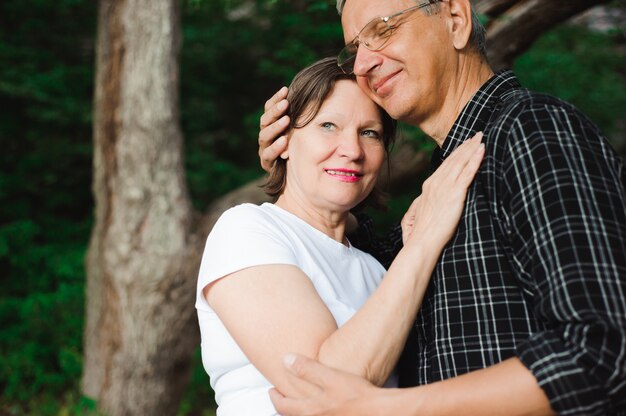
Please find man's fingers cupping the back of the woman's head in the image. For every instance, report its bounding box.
[259,87,289,172]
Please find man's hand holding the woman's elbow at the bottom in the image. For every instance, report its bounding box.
[270,354,382,416]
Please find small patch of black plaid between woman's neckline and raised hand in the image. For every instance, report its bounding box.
[348,213,402,269]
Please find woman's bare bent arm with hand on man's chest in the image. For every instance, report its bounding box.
[204,133,483,396]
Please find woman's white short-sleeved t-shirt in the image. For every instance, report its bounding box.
[196,203,385,416]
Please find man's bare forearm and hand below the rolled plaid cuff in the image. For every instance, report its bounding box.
[270,355,554,416]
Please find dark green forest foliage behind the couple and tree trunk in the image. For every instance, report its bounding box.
[0,0,626,415]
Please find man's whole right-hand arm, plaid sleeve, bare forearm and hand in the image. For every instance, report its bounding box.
[272,101,626,415]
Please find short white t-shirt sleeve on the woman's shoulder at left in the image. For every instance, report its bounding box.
[196,204,298,309]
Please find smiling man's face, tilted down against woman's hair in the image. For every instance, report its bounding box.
[341,0,457,125]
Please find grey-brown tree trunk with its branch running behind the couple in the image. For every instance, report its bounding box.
[82,0,599,416]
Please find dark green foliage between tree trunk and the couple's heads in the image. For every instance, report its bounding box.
[181,0,342,209]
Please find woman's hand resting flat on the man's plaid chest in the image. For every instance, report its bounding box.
[401,132,485,250]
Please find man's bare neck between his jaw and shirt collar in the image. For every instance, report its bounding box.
[418,57,494,147]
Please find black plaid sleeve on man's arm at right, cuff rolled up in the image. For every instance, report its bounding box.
[496,100,626,415]
